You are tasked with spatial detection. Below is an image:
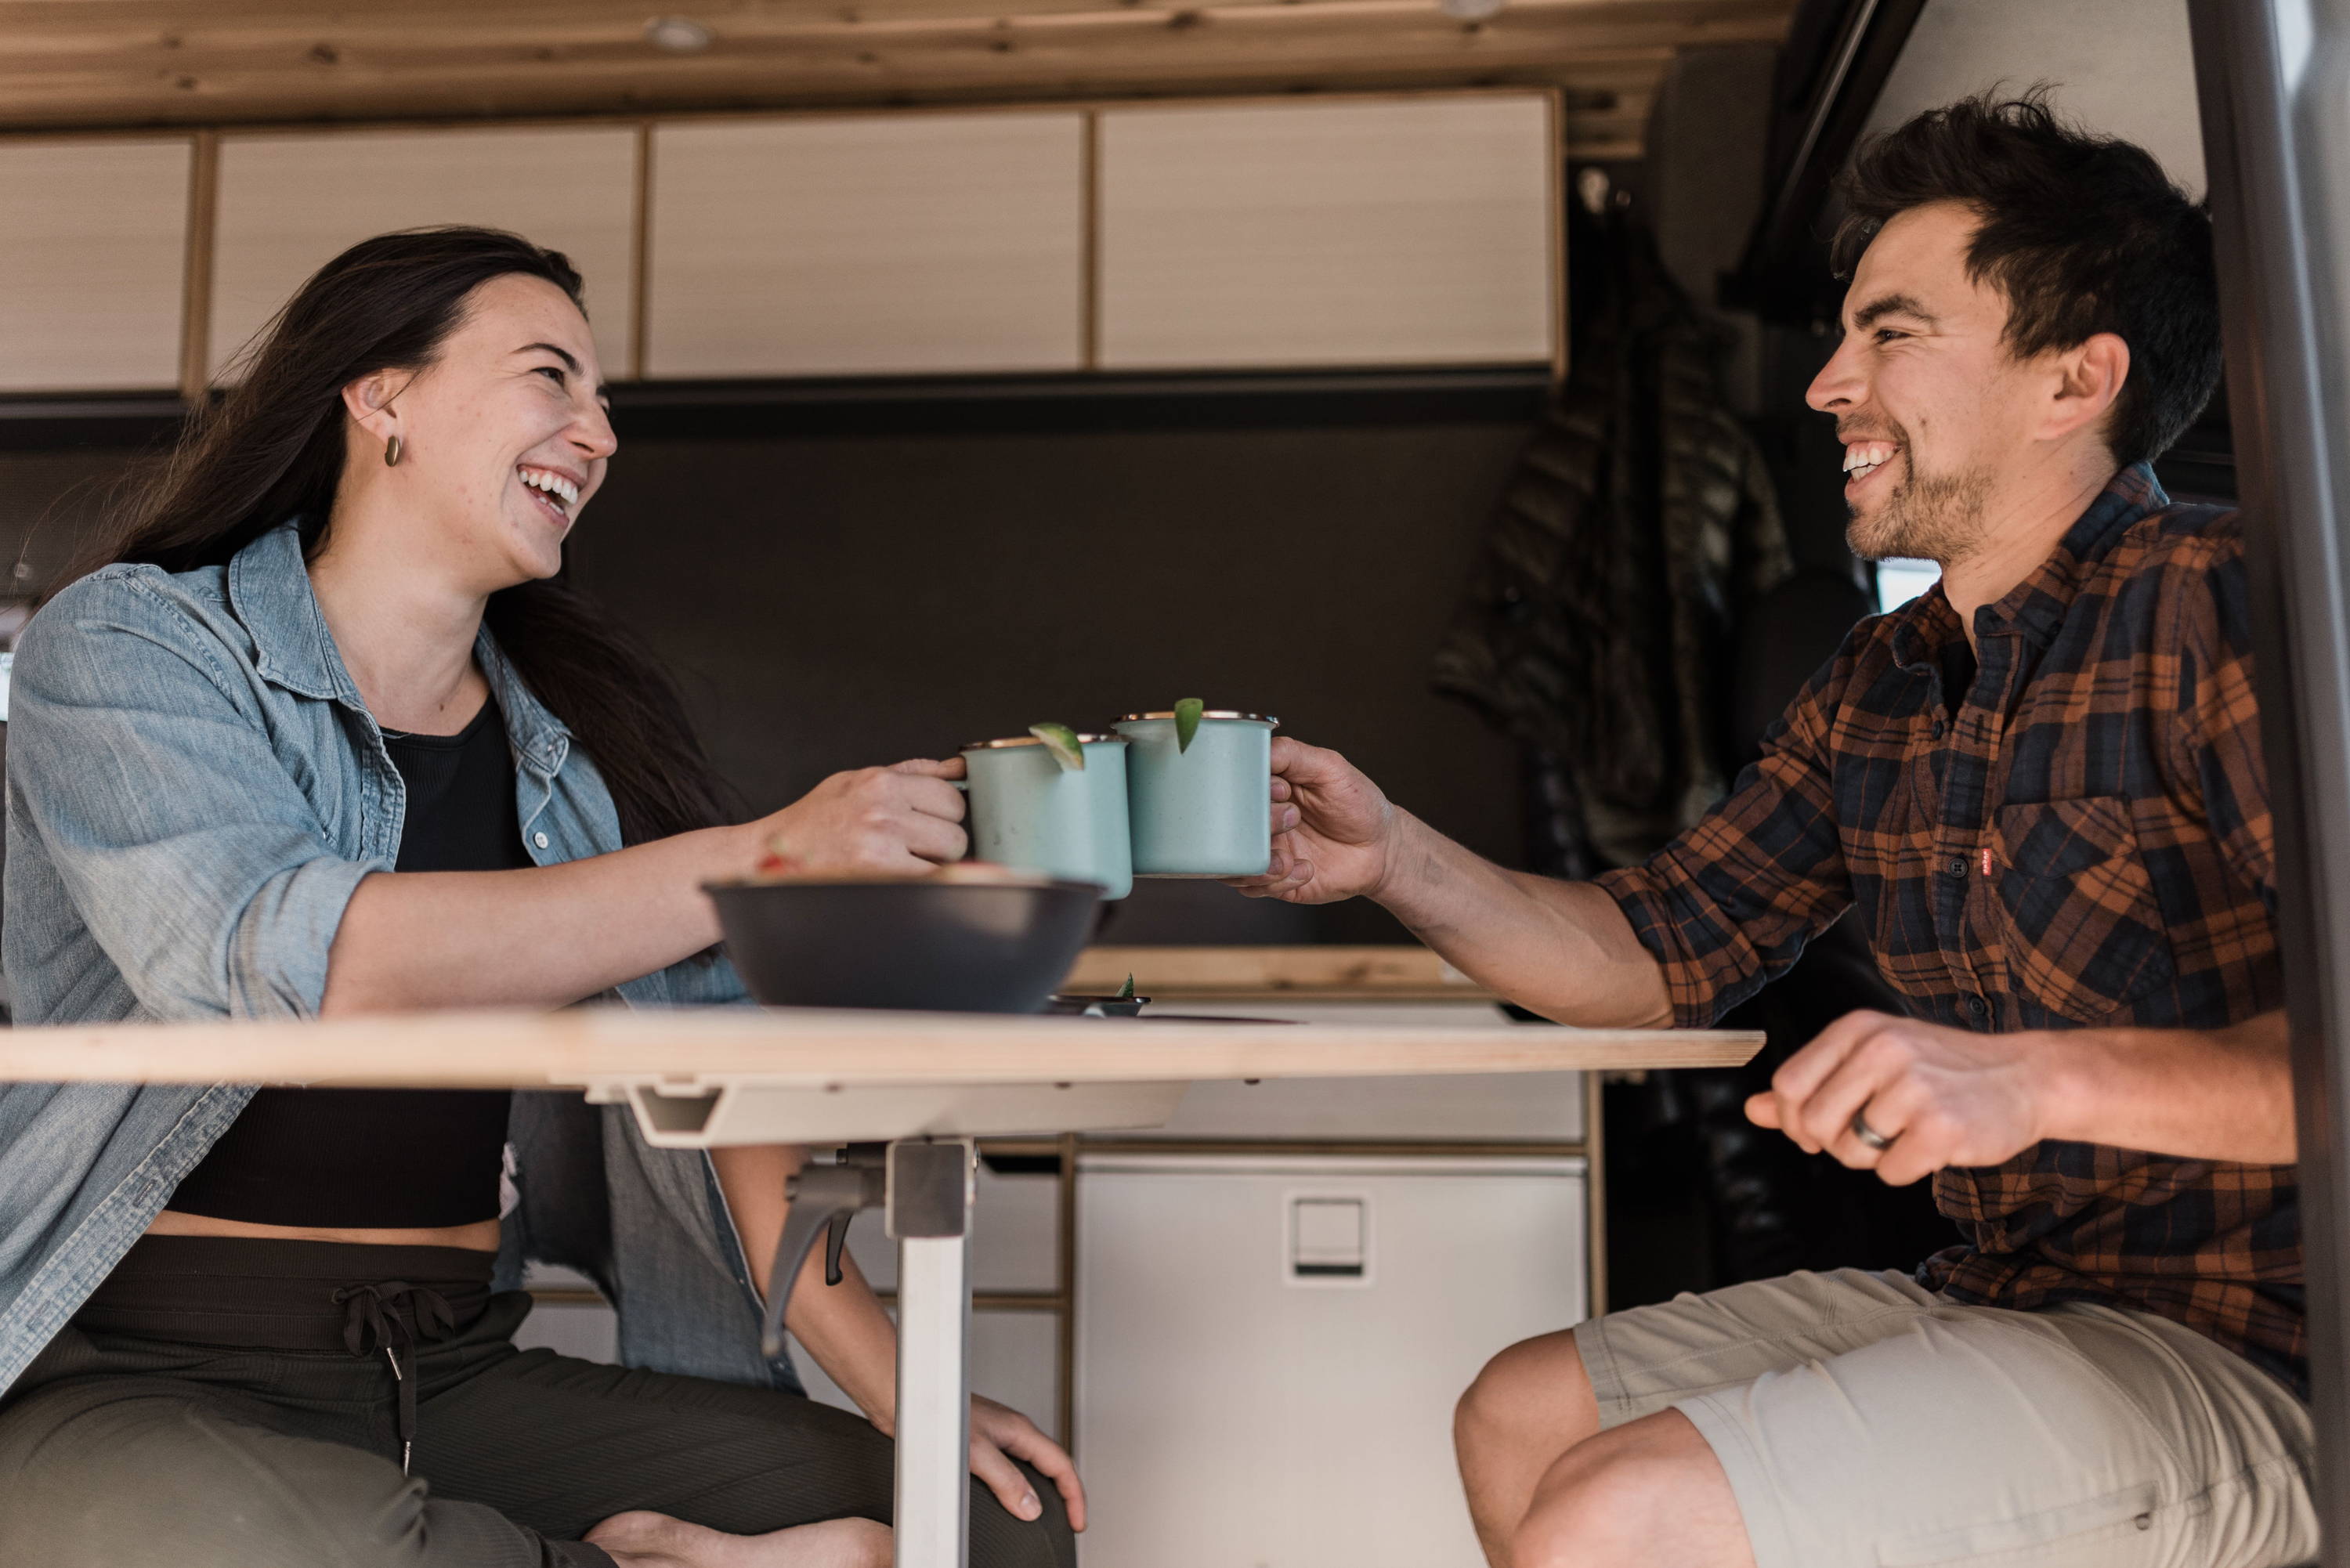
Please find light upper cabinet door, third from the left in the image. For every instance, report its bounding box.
[646,113,1086,376]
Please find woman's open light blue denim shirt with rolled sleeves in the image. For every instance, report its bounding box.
[0,524,797,1392]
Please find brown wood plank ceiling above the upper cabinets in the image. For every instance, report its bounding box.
[0,0,1795,157]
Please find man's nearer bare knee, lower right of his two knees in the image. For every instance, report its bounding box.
[1511,1411,1755,1568]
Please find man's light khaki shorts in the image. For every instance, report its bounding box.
[1574,1270,2317,1568]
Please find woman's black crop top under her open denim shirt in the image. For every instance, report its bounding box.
[169,700,531,1230]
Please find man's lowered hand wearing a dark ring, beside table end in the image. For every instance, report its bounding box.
[1746,1013,2049,1187]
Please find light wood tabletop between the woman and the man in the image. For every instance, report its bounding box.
[0,1009,1762,1089]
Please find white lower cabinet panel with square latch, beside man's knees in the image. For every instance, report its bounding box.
[1076,1154,1586,1568]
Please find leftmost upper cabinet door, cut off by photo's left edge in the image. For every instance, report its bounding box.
[0,139,190,392]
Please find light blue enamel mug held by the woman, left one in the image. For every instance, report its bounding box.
[964,735,1135,898]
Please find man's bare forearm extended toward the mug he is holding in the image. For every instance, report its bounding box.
[1372,809,1673,1028]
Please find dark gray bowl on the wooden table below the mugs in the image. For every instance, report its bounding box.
[703,882,1102,1013]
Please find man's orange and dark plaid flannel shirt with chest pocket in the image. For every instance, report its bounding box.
[1600,465,2308,1396]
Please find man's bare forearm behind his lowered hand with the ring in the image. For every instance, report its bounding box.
[2044,1013,2296,1166]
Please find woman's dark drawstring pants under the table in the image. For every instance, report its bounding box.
[0,1293,1076,1568]
